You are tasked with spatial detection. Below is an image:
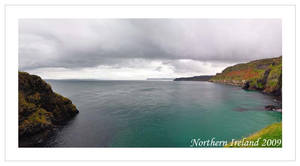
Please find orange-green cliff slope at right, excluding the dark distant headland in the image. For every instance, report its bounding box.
[209,56,282,96]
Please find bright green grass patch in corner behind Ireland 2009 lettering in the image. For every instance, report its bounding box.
[225,122,282,148]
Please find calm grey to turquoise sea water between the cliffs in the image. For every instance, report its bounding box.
[46,80,281,147]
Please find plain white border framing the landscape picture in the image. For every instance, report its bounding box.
[4,5,296,161]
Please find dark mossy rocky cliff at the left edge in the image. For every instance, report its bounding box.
[19,72,79,146]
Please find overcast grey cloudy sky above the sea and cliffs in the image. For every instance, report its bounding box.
[19,19,282,80]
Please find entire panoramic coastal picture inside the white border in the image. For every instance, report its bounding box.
[18,18,284,148]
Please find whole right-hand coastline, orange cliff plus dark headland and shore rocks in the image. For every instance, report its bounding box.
[174,56,282,112]
